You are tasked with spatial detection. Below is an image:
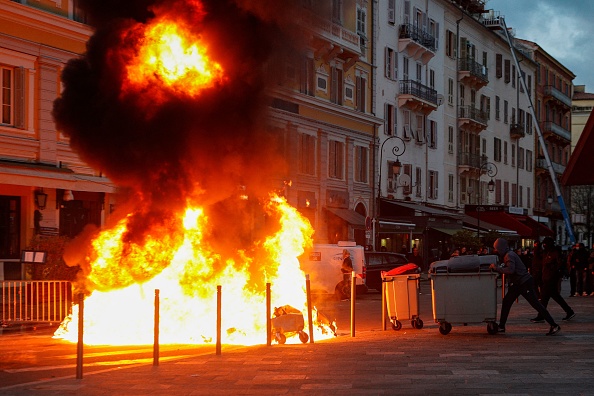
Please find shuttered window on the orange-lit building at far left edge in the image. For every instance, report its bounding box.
[0,66,25,129]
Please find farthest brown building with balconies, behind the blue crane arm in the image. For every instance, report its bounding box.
[517,40,575,245]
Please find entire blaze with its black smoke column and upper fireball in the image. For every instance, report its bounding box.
[53,0,333,345]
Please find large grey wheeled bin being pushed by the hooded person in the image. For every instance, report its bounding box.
[429,255,498,335]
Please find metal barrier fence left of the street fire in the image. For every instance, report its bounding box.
[0,281,72,323]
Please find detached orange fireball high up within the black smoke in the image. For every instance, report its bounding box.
[126,18,224,96]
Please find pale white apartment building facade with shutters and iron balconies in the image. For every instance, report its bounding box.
[376,0,544,256]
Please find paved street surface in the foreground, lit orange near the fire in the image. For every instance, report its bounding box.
[0,281,594,395]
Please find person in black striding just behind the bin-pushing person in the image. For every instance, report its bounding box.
[530,237,575,323]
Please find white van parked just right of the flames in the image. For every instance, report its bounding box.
[299,241,367,294]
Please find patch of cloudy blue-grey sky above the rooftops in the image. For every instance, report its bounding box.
[485,0,594,92]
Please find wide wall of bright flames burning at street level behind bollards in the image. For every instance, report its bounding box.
[55,195,335,345]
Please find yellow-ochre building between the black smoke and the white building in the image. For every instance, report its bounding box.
[270,0,382,245]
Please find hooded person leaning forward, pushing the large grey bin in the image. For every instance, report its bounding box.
[490,238,561,335]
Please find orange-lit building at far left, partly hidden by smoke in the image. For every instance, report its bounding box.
[0,0,115,279]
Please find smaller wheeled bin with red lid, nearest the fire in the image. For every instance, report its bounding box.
[382,271,423,330]
